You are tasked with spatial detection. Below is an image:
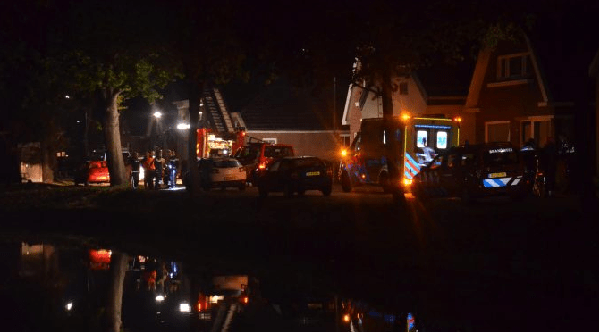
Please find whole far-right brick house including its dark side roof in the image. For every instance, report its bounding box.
[464,27,595,146]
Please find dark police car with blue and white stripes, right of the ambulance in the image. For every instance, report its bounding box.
[412,142,527,202]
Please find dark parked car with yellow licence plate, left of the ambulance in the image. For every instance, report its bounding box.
[257,156,333,197]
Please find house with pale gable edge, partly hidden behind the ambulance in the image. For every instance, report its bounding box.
[342,62,472,143]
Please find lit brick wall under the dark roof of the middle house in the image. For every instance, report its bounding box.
[247,130,348,161]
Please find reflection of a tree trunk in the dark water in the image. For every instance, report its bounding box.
[106,251,129,332]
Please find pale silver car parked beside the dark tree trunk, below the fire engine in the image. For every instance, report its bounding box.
[183,157,247,190]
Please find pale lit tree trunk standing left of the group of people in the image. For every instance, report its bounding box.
[104,91,128,186]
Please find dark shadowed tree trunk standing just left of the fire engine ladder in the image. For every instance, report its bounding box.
[189,78,202,196]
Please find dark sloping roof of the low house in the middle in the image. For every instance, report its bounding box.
[240,78,347,130]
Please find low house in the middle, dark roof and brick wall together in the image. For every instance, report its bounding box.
[238,79,349,161]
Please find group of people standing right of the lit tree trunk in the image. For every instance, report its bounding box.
[131,150,179,189]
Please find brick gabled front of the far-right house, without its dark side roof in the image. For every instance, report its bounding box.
[464,36,572,146]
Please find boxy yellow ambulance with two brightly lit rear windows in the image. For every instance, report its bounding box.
[338,113,461,193]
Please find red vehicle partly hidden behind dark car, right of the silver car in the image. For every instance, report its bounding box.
[233,142,295,184]
